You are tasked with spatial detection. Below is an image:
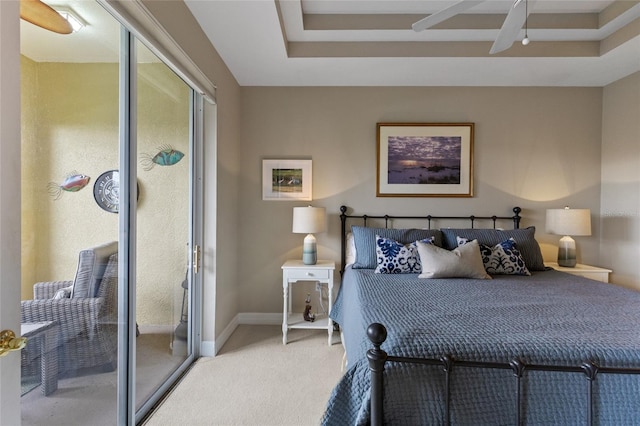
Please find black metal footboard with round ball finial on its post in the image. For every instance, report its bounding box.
[367,323,640,426]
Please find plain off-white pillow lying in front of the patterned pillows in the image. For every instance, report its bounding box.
[417,240,491,280]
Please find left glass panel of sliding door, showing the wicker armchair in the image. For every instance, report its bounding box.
[19,2,121,425]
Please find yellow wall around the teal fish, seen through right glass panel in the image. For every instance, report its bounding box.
[136,64,191,324]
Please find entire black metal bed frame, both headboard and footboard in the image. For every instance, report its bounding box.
[340,206,640,426]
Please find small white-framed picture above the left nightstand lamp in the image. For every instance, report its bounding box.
[262,160,311,201]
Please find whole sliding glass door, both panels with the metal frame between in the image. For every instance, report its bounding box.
[21,1,202,425]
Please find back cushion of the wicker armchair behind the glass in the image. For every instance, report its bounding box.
[71,241,118,298]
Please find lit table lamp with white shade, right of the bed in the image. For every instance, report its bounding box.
[546,207,591,268]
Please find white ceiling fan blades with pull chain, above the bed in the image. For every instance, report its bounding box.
[411,0,536,54]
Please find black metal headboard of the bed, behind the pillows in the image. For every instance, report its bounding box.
[340,206,522,275]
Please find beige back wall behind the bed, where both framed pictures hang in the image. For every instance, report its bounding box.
[238,87,607,312]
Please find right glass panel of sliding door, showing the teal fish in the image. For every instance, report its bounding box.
[135,43,192,410]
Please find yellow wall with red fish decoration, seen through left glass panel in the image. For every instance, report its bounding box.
[22,57,118,298]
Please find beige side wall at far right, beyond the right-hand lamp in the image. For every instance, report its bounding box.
[600,72,640,290]
